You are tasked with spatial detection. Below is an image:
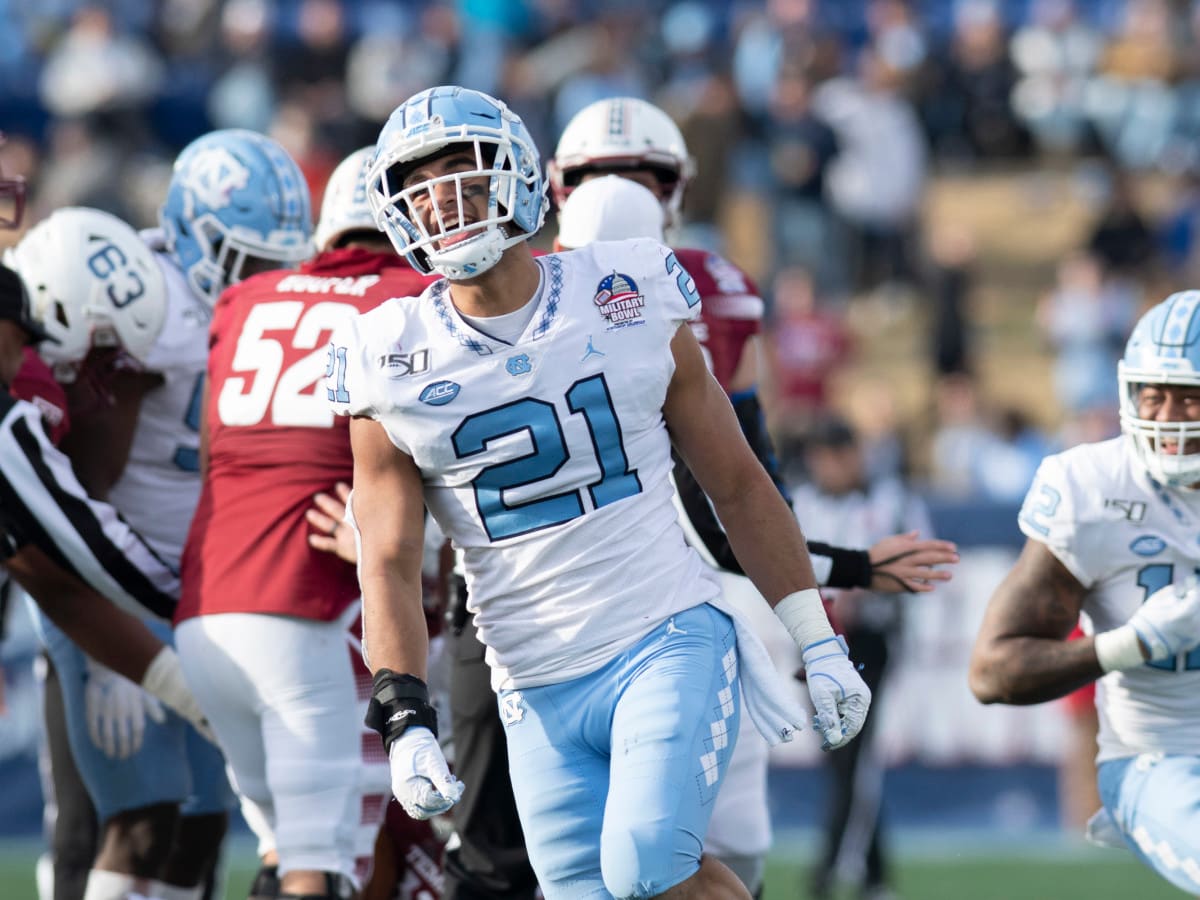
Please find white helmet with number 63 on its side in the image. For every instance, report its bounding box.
[5,206,167,382]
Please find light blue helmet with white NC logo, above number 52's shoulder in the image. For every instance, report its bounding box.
[158,128,312,304]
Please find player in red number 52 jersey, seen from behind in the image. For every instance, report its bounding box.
[175,149,439,900]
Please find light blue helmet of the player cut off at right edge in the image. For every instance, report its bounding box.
[1117,290,1200,486]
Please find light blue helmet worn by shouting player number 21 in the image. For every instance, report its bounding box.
[367,86,550,281]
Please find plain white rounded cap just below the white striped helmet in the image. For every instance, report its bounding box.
[558,175,665,250]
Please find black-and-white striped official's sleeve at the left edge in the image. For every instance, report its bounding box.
[0,397,179,622]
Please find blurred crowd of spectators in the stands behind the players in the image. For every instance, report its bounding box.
[11,0,1200,502]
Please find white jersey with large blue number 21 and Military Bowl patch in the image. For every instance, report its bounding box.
[326,240,718,690]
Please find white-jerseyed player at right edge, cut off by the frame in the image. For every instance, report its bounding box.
[970,290,1200,894]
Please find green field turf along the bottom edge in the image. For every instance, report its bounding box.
[0,841,1187,900]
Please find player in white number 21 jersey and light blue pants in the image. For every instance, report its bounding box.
[326,86,870,900]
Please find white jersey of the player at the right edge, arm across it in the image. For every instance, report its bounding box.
[1020,437,1200,762]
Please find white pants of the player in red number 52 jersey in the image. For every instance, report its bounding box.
[175,612,364,882]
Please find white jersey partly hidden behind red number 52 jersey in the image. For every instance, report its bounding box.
[108,234,210,565]
